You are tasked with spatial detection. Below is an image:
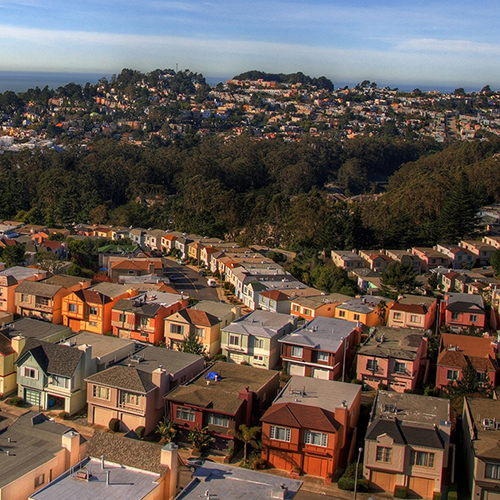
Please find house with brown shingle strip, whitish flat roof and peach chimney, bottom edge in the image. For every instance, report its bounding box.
[29,432,180,500]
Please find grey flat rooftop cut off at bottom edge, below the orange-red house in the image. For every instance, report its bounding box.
[175,462,302,500]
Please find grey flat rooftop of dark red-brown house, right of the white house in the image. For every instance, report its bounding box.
[279,316,356,352]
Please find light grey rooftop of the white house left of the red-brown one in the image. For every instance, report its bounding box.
[223,310,296,338]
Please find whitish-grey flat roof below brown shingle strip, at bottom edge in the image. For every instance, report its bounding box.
[30,458,160,500]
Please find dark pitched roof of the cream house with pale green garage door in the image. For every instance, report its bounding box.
[16,338,83,377]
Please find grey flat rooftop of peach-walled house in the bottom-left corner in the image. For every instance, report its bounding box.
[0,412,83,488]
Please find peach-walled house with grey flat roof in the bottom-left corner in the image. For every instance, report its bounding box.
[0,411,87,500]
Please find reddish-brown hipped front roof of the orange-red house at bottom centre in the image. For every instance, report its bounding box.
[261,403,340,432]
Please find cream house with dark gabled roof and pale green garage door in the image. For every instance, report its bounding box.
[12,337,94,414]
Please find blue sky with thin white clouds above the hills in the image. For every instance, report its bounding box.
[0,0,500,90]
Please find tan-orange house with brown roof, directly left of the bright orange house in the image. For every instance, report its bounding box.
[15,274,91,324]
